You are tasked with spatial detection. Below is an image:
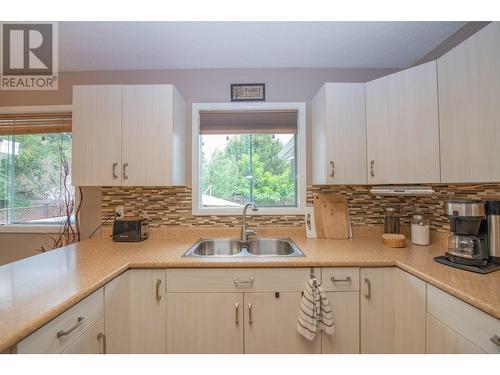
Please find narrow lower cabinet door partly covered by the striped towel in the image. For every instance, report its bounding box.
[321,291,359,354]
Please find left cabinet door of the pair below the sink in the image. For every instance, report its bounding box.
[167,293,244,354]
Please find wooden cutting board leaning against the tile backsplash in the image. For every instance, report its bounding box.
[313,193,351,239]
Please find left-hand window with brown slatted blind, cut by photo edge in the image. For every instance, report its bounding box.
[0,113,74,225]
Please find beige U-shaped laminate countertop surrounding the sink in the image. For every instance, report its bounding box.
[0,228,500,352]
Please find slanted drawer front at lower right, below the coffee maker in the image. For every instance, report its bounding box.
[427,284,500,353]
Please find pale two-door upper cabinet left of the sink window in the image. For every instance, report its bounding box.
[72,85,186,186]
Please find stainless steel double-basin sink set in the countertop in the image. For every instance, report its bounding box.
[183,237,305,258]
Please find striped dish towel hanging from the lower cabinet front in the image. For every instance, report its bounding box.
[297,278,335,340]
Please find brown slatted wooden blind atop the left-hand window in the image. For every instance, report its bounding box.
[0,112,71,135]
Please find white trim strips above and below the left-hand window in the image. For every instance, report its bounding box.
[0,104,76,234]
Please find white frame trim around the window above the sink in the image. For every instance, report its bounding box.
[191,102,307,216]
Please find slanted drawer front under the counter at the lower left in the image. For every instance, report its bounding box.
[17,288,104,354]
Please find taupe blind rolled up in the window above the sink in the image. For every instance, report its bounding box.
[200,109,297,134]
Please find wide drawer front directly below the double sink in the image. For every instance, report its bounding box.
[167,268,321,292]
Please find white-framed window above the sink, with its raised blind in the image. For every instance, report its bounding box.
[192,103,306,215]
